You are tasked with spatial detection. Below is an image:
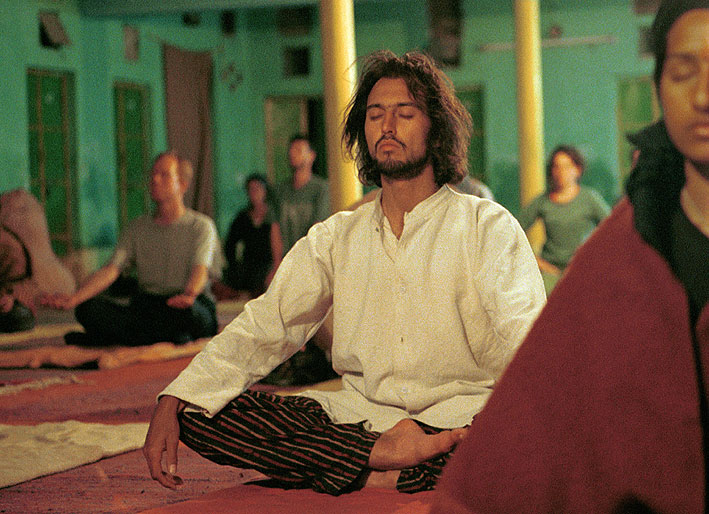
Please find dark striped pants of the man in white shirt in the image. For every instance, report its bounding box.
[179,391,450,495]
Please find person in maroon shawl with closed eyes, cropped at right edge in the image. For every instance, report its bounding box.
[431,0,709,514]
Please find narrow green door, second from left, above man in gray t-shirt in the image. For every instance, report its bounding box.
[113,82,151,228]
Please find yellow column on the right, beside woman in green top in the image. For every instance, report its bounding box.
[515,0,545,251]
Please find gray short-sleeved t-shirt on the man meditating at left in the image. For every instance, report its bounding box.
[111,209,219,295]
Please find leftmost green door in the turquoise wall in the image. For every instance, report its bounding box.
[27,69,76,256]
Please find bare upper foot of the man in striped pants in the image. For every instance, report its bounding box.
[368,419,467,470]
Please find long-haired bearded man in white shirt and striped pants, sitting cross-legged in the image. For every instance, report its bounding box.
[143,51,545,495]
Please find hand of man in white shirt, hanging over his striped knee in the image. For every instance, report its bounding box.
[143,396,184,489]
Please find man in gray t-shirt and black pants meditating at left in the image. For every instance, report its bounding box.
[43,153,219,346]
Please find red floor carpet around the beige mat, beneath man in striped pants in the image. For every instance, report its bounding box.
[0,358,431,514]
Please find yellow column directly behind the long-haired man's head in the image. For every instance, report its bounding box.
[320,0,362,212]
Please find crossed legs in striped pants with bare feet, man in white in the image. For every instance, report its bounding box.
[180,392,466,495]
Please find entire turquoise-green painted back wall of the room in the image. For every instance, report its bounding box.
[0,0,652,256]
